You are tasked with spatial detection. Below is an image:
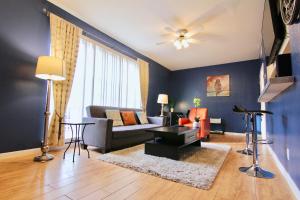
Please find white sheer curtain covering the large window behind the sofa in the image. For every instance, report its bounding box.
[66,38,142,121]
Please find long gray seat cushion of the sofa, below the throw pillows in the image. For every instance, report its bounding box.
[112,124,160,138]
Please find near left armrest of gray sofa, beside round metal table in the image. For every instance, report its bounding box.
[82,117,113,153]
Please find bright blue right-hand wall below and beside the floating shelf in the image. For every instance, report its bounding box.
[267,24,300,188]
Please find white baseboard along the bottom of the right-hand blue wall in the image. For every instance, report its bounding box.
[268,145,300,199]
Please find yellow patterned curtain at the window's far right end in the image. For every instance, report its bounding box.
[137,59,149,112]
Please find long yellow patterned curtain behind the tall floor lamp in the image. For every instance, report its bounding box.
[49,13,81,146]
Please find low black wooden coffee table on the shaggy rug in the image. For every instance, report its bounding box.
[145,126,201,160]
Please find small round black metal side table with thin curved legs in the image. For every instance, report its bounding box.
[60,122,95,162]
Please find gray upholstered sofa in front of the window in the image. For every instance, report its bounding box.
[83,106,164,153]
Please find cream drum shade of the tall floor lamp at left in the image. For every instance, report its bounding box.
[35,56,66,81]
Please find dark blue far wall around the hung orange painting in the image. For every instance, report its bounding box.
[170,60,260,132]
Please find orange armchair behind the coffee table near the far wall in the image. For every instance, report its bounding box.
[178,108,210,139]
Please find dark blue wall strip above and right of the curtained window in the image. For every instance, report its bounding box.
[45,2,170,115]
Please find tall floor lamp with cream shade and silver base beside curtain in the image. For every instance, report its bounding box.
[34,56,65,162]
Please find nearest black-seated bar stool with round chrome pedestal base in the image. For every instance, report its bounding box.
[233,106,274,179]
